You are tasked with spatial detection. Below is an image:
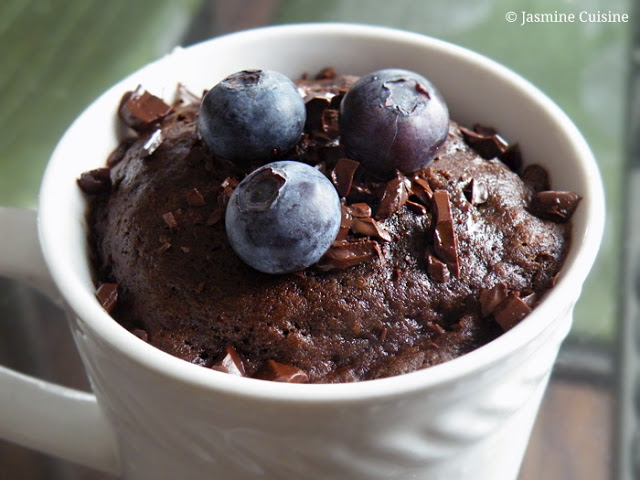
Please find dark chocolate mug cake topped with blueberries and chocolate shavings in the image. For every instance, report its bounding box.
[78,69,580,383]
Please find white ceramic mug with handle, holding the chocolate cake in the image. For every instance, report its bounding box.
[0,24,604,480]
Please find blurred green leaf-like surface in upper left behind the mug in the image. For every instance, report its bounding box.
[0,0,200,207]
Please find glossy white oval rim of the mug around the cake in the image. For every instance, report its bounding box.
[38,22,604,402]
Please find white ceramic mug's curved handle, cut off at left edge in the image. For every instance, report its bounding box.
[0,207,120,474]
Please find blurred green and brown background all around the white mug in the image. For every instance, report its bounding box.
[0,0,640,480]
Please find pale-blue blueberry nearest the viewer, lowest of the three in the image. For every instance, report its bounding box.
[225,160,341,273]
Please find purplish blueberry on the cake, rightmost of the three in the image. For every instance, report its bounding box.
[339,69,449,176]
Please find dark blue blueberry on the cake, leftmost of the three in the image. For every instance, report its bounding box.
[198,70,307,163]
